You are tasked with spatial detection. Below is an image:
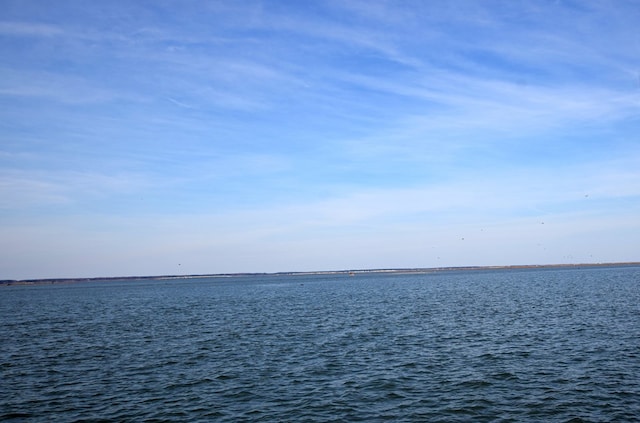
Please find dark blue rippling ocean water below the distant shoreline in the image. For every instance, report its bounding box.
[0,267,640,422]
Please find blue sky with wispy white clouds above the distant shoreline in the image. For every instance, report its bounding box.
[0,0,640,279]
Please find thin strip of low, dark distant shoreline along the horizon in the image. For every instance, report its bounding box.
[0,262,640,286]
